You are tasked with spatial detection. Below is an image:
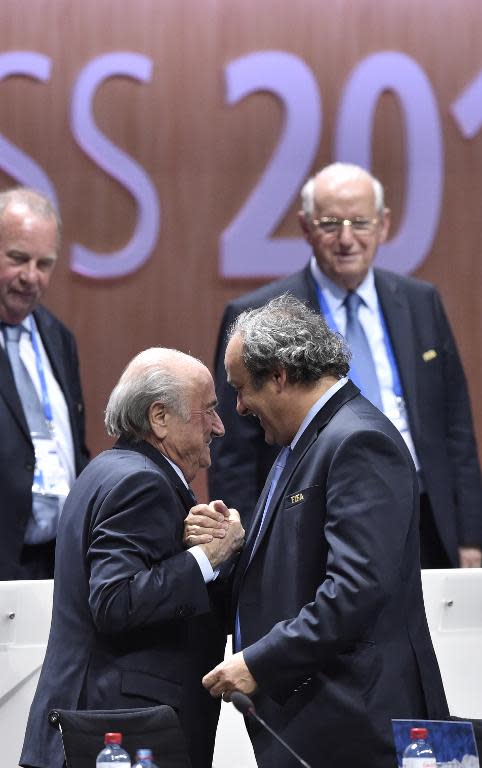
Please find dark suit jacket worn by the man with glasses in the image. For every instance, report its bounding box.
[209,266,482,566]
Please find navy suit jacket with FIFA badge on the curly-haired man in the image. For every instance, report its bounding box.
[233,382,448,768]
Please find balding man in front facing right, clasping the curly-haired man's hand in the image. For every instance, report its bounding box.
[20,348,244,768]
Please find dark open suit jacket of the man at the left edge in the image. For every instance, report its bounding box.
[0,307,89,580]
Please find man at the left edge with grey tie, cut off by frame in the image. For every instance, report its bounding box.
[0,188,89,580]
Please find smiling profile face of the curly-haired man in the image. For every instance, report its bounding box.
[224,335,293,445]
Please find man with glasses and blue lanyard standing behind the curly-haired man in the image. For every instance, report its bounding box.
[209,163,482,568]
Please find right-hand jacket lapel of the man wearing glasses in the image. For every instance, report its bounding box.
[374,269,419,433]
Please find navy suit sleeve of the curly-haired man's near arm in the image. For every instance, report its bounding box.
[243,431,418,704]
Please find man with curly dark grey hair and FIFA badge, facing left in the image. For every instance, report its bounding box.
[201,295,448,768]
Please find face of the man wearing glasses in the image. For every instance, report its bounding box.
[300,172,390,290]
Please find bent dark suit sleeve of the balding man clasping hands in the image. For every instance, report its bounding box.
[87,471,210,633]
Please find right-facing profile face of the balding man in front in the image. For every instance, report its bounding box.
[150,360,224,483]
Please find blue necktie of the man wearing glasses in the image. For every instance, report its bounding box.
[344,292,383,411]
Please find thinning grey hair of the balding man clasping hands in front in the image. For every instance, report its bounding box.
[104,347,199,441]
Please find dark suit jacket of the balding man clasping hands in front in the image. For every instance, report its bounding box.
[20,441,224,768]
